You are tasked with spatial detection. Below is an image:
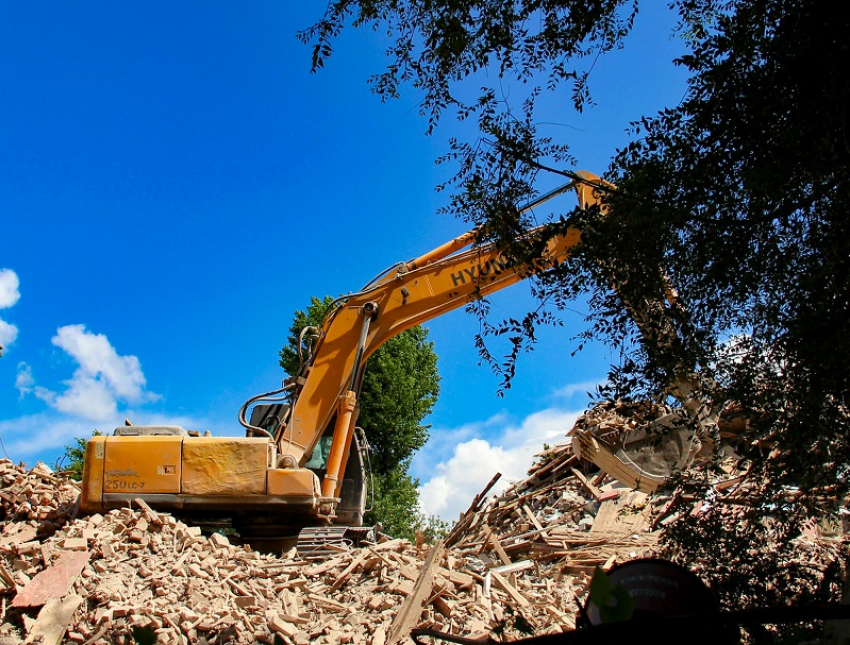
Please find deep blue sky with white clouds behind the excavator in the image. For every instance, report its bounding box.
[0,1,684,518]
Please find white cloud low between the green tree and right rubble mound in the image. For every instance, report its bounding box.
[414,408,581,520]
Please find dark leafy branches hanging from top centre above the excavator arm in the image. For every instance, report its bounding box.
[299,0,638,388]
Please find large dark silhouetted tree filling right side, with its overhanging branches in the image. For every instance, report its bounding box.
[301,0,850,628]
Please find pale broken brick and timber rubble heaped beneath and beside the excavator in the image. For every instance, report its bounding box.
[0,406,844,645]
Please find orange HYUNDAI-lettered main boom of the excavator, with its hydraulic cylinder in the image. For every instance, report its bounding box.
[276,211,580,496]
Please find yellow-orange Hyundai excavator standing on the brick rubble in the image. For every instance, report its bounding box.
[81,172,708,542]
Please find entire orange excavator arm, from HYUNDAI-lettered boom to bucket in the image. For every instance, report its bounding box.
[284,172,717,498]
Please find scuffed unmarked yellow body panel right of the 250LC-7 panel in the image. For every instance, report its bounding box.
[182,437,269,495]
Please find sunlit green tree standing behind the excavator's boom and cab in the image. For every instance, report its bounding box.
[280,297,440,539]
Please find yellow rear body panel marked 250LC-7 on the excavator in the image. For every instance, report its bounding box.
[103,436,183,495]
